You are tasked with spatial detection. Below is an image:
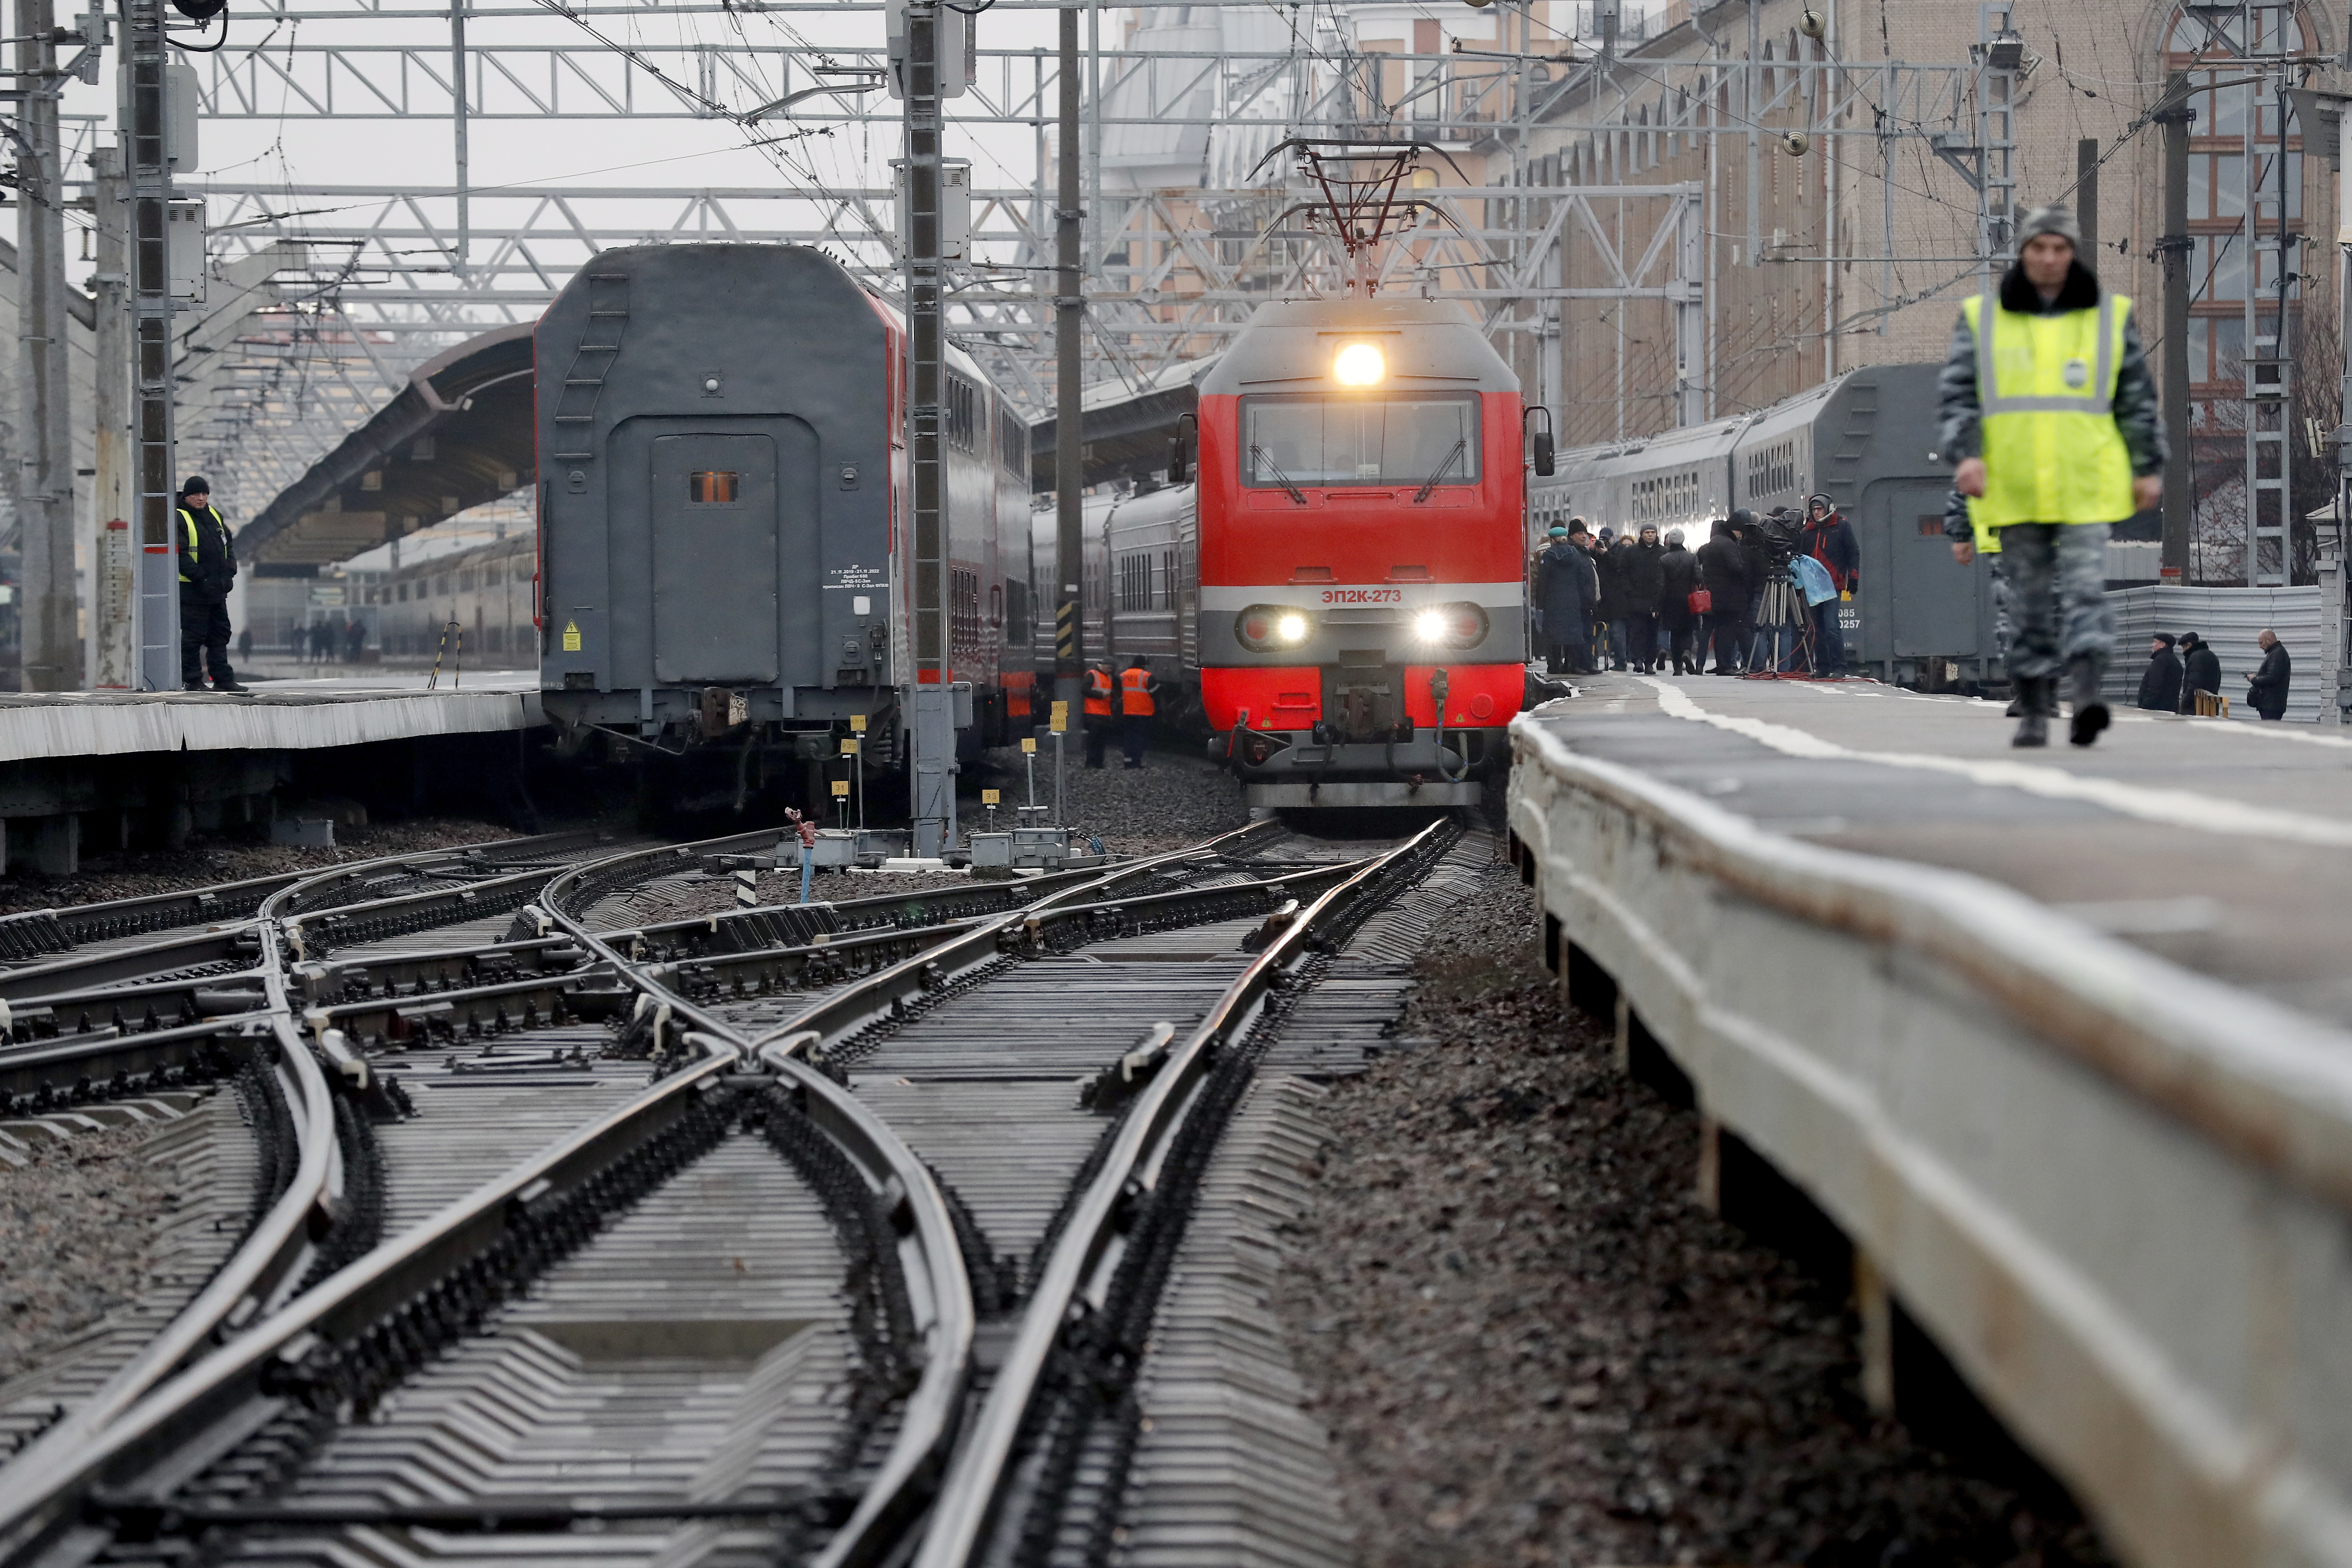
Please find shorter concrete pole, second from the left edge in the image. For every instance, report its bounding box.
[89,146,139,691]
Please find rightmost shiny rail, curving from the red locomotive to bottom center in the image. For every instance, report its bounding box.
[913,823,1444,1568]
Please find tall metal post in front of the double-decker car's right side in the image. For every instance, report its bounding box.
[906,0,962,856]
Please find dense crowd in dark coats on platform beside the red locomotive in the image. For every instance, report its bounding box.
[1536,496,1863,675]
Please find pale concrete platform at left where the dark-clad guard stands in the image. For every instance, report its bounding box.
[0,670,546,762]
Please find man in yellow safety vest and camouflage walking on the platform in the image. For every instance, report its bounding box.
[1936,207,2166,745]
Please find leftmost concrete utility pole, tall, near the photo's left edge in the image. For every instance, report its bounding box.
[16,0,83,691]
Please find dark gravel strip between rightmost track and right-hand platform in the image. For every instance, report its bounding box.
[1280,879,2107,1568]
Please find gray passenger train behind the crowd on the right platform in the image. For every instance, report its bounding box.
[1529,364,1999,684]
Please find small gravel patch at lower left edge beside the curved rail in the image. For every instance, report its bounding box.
[0,1126,179,1384]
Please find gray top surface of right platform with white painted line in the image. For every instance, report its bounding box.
[1538,675,2352,1023]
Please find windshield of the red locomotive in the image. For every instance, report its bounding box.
[1242,392,1477,489]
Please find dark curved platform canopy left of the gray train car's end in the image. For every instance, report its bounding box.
[238,322,536,574]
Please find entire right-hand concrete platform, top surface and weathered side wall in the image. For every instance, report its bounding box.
[1510,675,2352,1568]
